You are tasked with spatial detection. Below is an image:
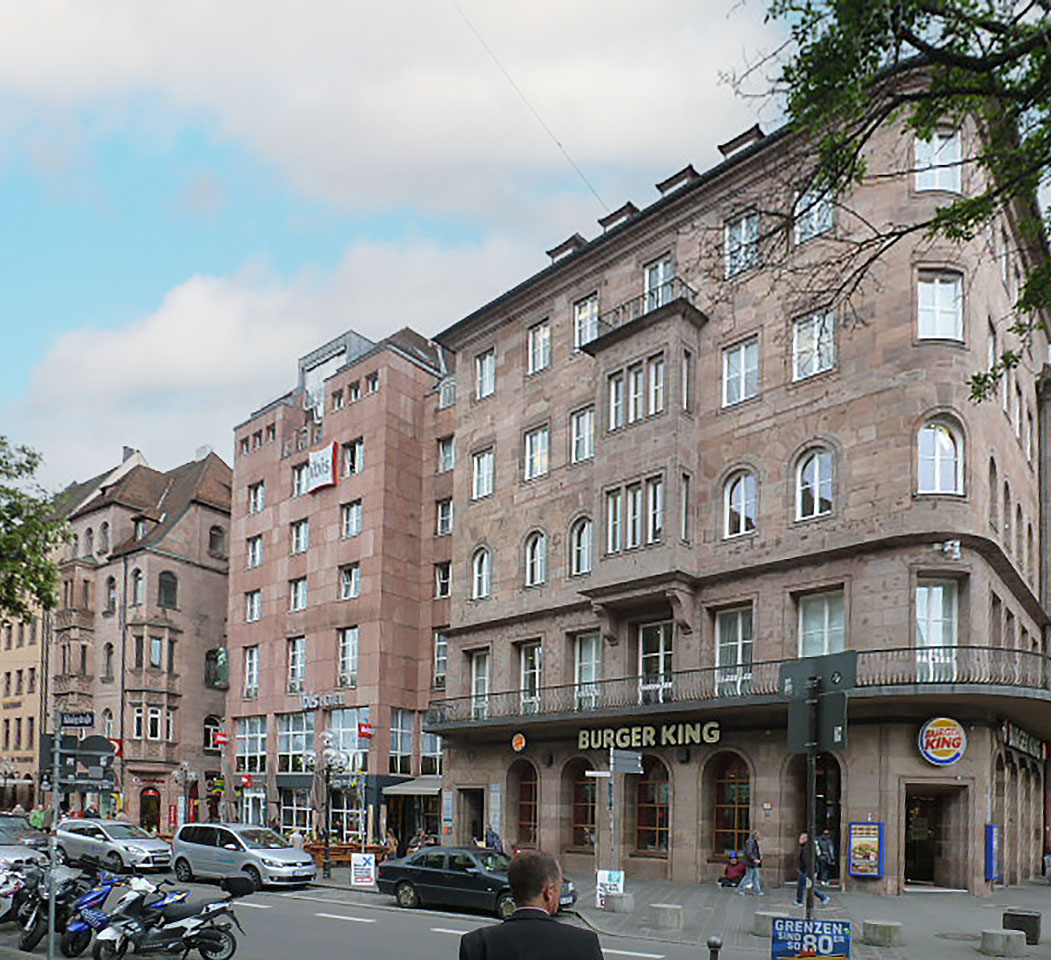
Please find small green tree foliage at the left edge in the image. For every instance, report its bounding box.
[0,436,65,619]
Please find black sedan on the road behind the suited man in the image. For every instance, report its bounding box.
[376,846,577,918]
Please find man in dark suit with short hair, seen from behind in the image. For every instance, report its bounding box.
[459,850,602,960]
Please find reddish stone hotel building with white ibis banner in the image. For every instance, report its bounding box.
[227,329,454,839]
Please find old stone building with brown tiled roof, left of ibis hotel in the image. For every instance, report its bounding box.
[48,447,230,831]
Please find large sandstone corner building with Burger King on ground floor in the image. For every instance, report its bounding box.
[427,116,1051,893]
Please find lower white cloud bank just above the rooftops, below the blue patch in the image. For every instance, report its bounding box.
[8,231,534,488]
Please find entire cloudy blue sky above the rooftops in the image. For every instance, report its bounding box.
[0,0,768,487]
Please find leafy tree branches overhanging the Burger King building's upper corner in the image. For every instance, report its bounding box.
[745,0,1051,400]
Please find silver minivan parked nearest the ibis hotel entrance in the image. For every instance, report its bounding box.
[171,823,317,890]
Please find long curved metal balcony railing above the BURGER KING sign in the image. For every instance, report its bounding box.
[427,647,1051,726]
